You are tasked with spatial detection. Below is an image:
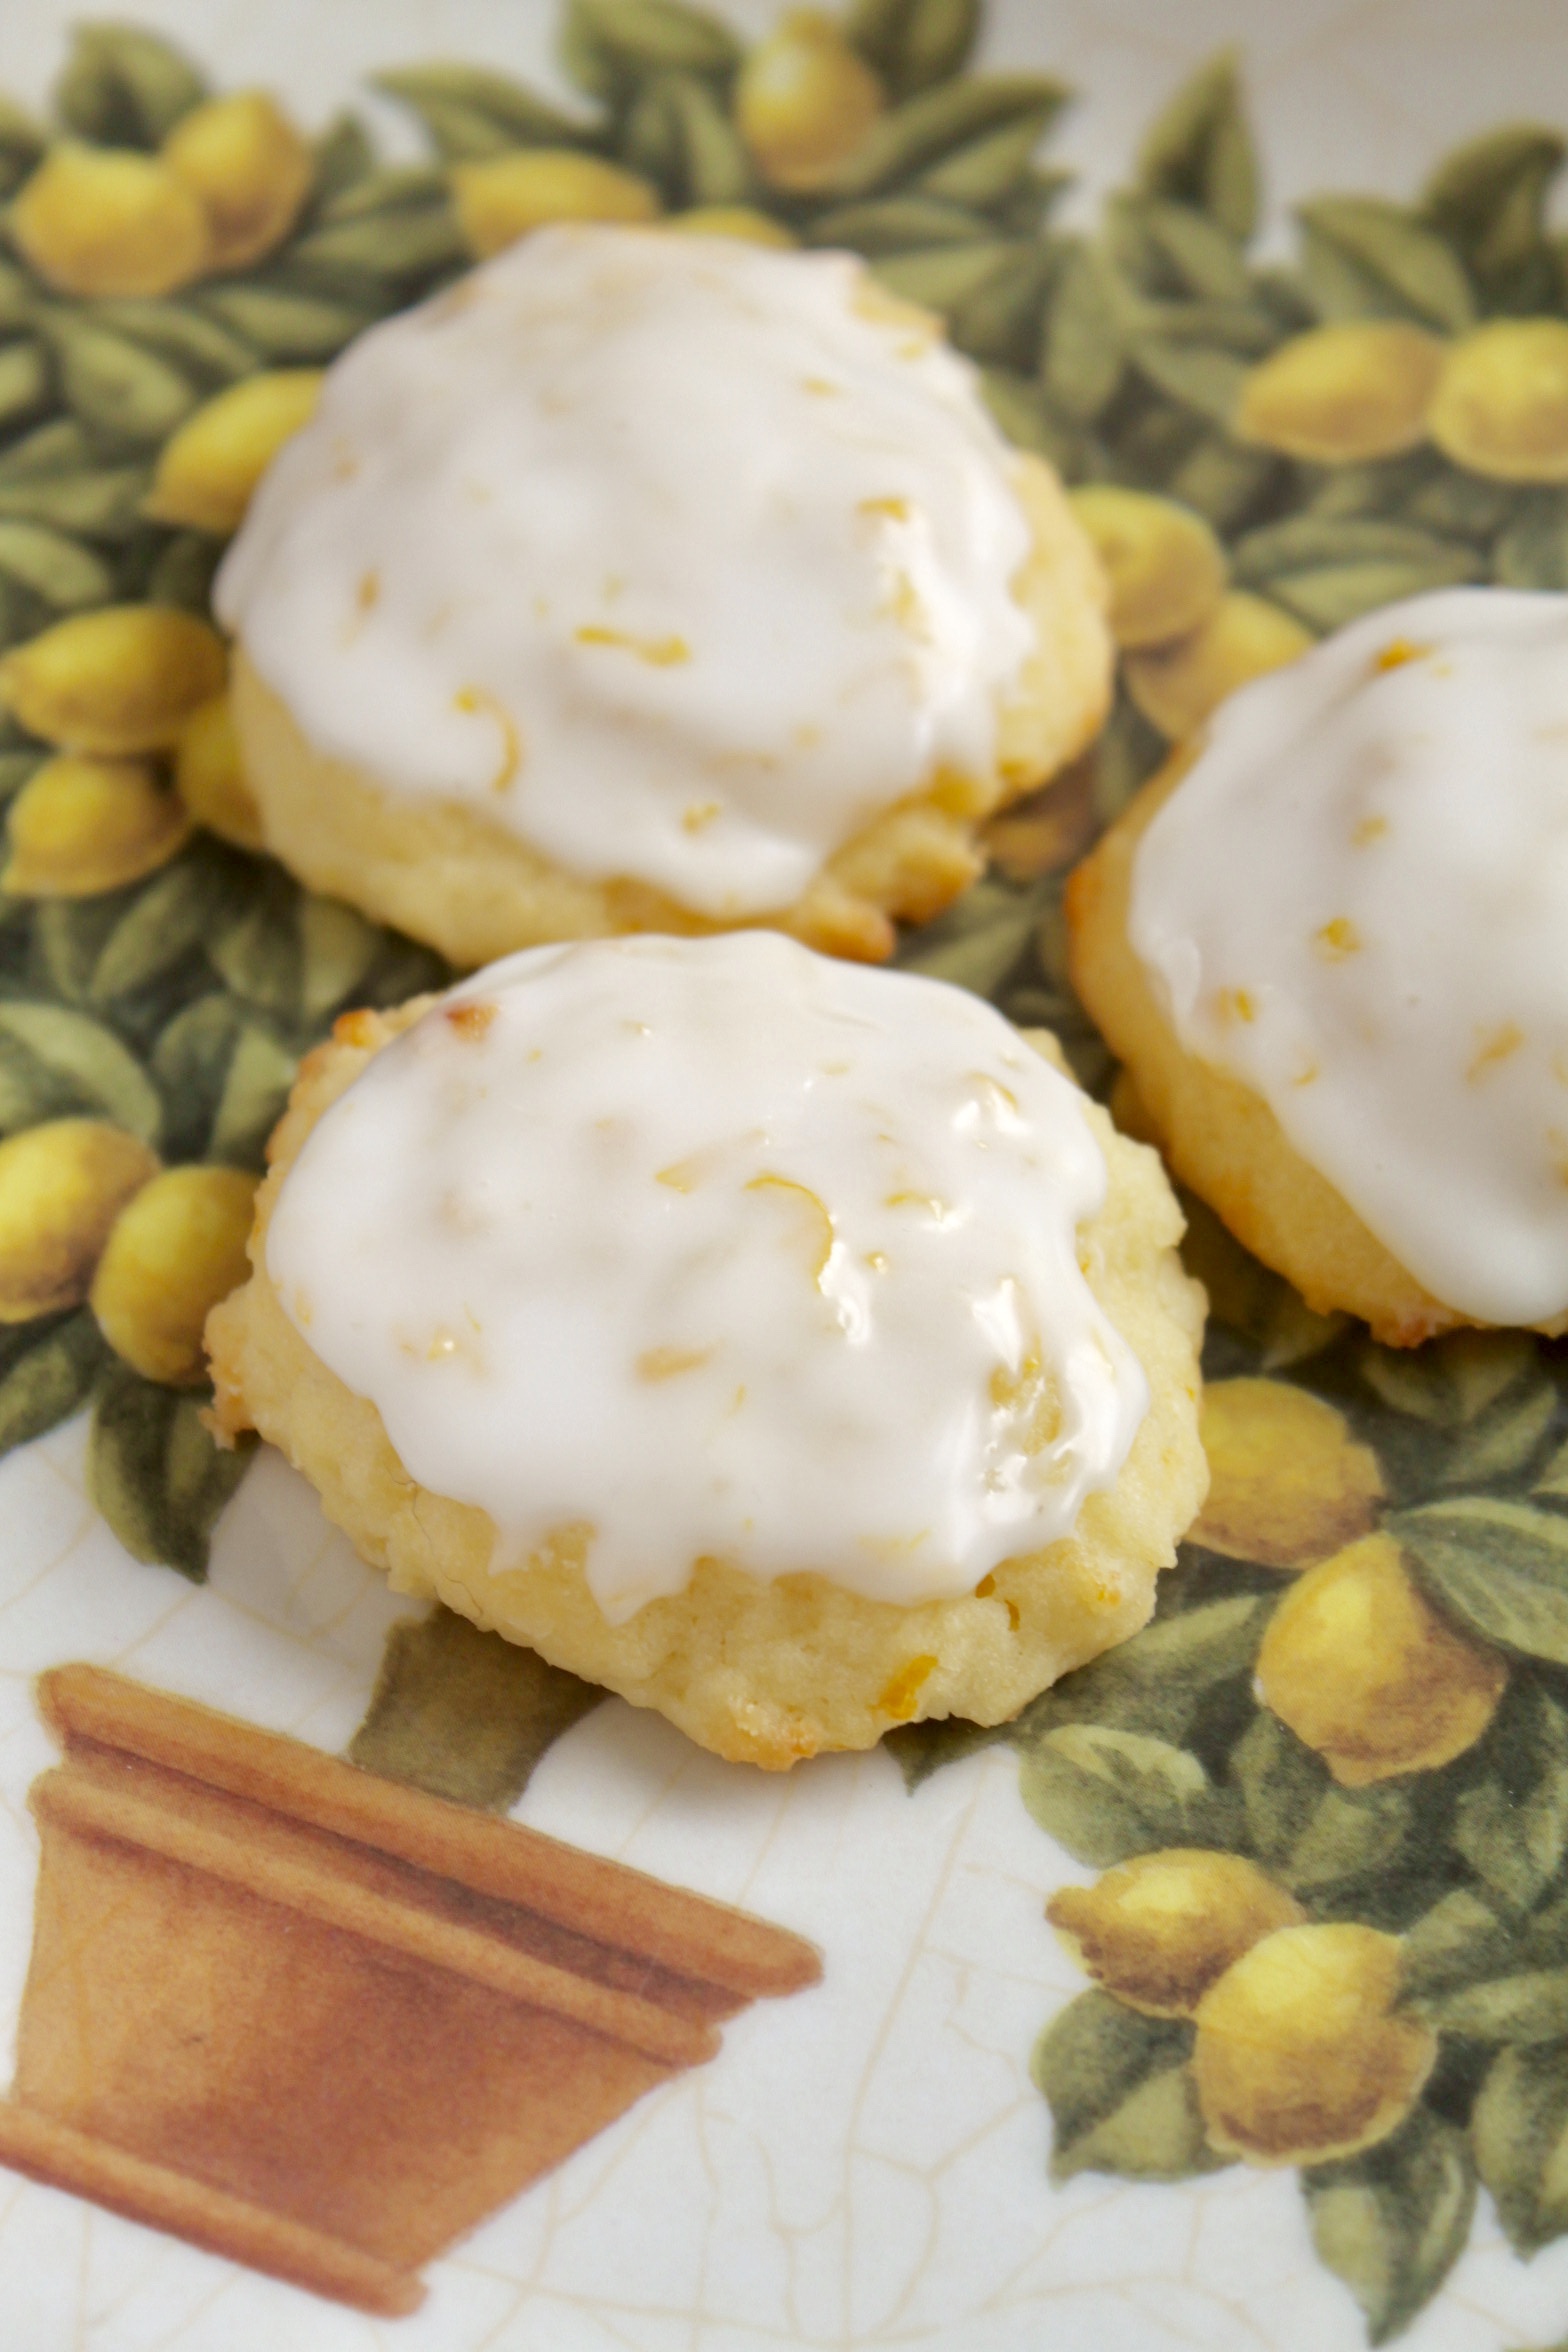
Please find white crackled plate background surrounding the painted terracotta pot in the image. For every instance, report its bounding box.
[0,1428,1568,2352]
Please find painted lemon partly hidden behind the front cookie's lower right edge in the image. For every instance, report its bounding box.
[1192,1381,1382,1569]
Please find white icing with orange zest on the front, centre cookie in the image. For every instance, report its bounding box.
[266,934,1147,1623]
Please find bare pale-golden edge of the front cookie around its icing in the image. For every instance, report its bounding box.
[207,1000,1208,1771]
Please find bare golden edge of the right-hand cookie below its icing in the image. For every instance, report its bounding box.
[1067,748,1568,1348]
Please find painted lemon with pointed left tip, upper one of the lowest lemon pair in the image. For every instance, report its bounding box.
[1046,1846,1305,2018]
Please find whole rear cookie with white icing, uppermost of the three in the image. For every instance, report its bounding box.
[216,226,1110,964]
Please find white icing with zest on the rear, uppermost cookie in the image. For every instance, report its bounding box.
[216,226,1032,920]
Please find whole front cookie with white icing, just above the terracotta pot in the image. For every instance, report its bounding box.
[209,931,1206,1769]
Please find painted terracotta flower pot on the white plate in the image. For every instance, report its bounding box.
[0,1665,820,2314]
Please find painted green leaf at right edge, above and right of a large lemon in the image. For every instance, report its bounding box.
[1389,1496,1568,1665]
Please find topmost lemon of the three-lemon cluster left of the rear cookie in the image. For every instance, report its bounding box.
[0,604,228,760]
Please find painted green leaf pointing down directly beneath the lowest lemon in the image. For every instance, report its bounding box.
[1302,2107,1476,2345]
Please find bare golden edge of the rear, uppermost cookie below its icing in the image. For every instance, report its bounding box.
[233,456,1112,967]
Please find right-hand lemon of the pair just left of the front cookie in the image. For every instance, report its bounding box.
[92,1167,256,1388]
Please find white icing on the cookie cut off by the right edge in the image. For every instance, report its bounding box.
[1131,588,1568,1324]
